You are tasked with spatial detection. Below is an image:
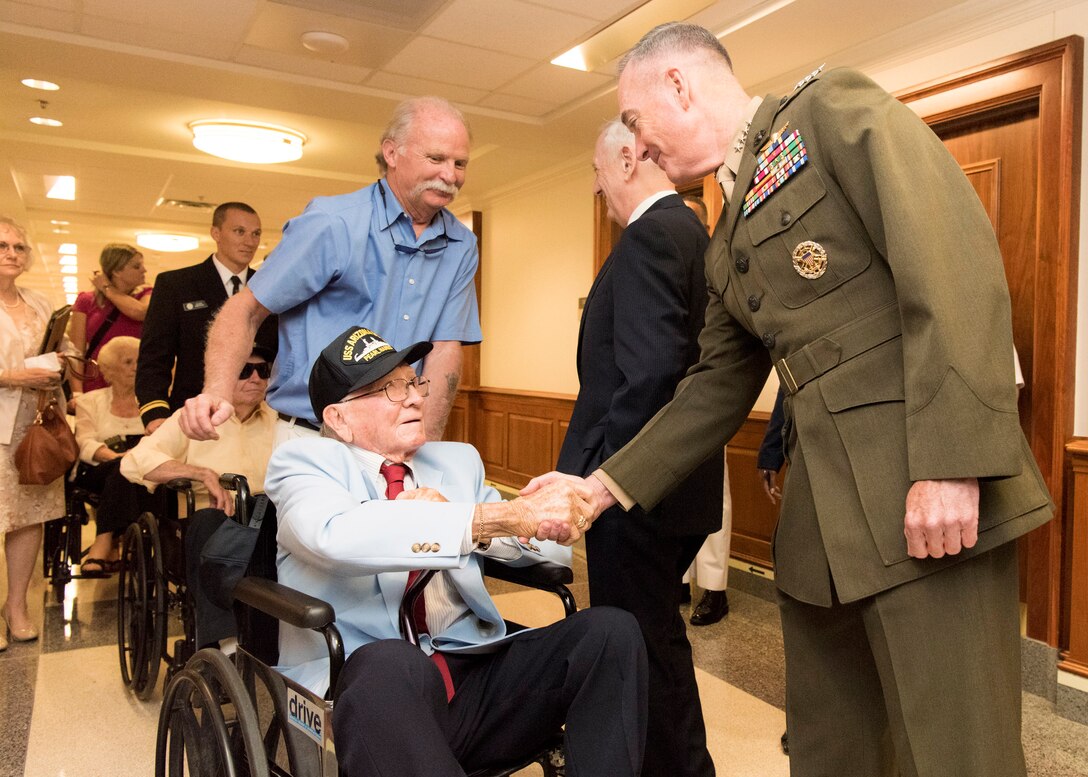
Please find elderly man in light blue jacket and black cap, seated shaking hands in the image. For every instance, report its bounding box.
[265,326,646,777]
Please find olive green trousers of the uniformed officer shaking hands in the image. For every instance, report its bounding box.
[779,539,1025,777]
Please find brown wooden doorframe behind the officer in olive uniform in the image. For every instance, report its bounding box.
[897,36,1084,646]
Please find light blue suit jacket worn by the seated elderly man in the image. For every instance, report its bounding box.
[264,437,570,693]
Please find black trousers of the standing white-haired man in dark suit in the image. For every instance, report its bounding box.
[585,508,714,777]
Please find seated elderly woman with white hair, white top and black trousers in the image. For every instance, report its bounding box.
[75,335,147,575]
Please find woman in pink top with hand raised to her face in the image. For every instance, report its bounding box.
[69,243,151,393]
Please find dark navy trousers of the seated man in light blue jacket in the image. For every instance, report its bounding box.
[333,607,646,777]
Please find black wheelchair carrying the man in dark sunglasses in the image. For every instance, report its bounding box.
[118,473,274,700]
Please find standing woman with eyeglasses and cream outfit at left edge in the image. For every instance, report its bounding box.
[0,215,64,650]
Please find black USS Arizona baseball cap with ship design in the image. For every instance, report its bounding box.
[310,326,434,421]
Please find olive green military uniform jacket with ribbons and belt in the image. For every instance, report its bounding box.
[603,70,1052,605]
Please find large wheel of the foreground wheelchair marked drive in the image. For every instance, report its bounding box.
[154,649,269,777]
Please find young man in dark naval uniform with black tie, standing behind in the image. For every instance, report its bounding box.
[136,202,276,434]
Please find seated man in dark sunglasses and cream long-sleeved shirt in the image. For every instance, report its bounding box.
[121,344,276,515]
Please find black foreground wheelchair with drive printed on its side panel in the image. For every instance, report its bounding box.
[156,539,577,777]
